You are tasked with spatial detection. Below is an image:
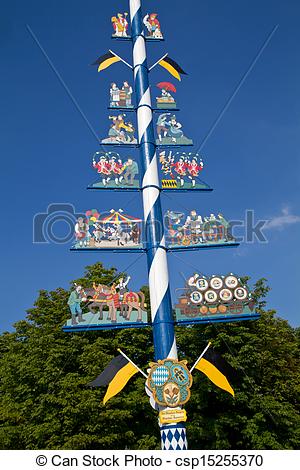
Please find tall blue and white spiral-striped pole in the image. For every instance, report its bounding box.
[129,0,187,450]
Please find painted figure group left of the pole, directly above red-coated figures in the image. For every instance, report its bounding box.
[101,114,137,144]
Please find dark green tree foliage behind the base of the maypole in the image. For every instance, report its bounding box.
[0,263,300,449]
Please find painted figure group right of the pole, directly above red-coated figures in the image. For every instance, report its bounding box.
[156,113,193,145]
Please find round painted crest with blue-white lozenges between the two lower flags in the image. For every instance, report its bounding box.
[147,359,193,408]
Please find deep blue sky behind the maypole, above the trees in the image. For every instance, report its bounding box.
[0,0,300,330]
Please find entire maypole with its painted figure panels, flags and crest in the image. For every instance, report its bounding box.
[63,0,259,450]
